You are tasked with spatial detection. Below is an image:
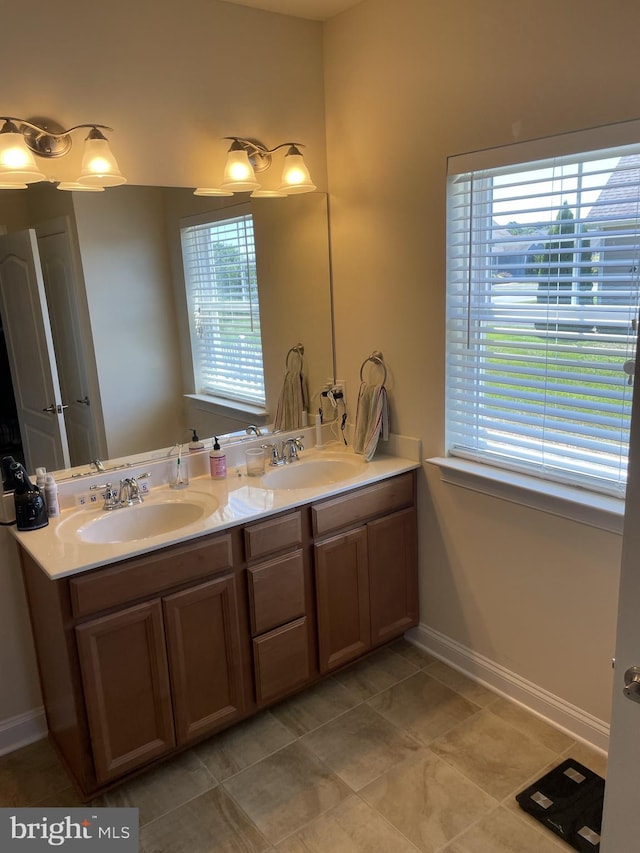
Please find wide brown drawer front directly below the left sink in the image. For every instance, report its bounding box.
[69,536,233,617]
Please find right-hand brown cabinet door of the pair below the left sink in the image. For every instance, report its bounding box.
[164,575,244,744]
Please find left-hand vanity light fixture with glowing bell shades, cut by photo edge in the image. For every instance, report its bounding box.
[0,116,127,192]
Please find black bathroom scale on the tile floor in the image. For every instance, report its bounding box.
[516,758,604,851]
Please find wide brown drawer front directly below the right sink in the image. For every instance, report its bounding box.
[311,471,414,537]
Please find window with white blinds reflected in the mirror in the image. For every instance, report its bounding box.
[181,208,265,406]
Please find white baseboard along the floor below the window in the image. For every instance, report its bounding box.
[406,624,609,752]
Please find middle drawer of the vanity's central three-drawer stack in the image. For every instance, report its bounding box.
[247,551,305,634]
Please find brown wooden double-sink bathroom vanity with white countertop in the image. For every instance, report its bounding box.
[17,446,418,798]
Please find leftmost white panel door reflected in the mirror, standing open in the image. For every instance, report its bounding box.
[0,230,69,471]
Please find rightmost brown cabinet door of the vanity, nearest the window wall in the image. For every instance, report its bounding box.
[367,509,418,646]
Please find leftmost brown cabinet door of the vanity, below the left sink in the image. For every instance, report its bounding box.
[75,599,175,782]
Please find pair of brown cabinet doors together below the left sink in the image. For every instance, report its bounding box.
[76,564,245,782]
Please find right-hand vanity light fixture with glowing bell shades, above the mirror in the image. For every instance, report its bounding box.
[194,136,316,198]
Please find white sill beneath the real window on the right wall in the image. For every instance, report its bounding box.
[425,456,624,535]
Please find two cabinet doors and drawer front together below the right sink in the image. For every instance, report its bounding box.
[312,474,418,673]
